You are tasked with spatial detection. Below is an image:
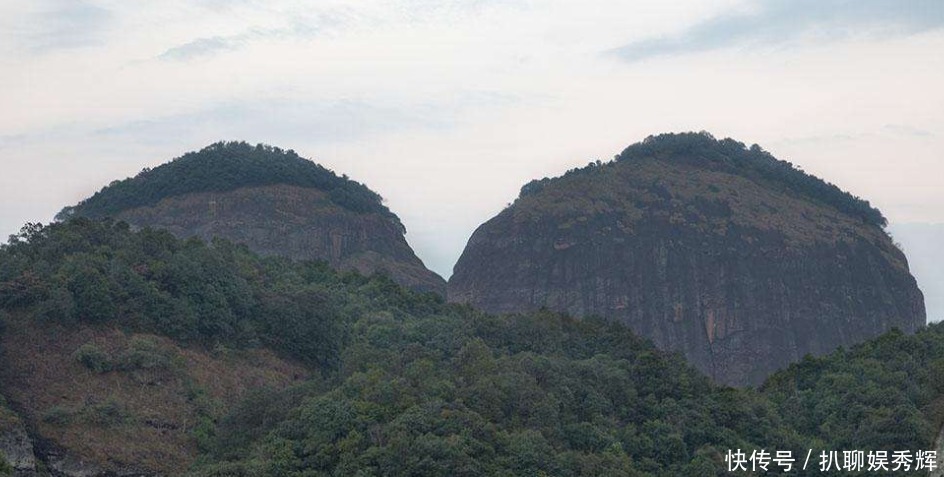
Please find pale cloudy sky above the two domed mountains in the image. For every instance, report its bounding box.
[0,0,944,286]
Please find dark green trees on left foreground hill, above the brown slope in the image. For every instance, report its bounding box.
[0,218,342,372]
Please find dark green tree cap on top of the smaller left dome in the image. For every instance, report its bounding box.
[58,142,399,222]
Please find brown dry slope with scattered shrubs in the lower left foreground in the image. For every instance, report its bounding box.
[0,317,308,475]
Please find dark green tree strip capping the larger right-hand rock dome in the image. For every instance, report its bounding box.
[521,132,888,227]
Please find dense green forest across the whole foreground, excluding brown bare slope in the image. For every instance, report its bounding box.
[0,218,944,476]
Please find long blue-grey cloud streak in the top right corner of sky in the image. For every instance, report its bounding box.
[613,0,944,61]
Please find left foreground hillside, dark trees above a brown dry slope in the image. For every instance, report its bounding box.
[0,218,330,476]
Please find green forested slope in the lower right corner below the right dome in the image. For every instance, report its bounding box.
[762,323,944,449]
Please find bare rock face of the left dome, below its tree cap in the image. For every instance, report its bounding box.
[115,184,445,295]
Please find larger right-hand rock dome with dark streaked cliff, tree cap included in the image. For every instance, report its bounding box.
[449,134,925,385]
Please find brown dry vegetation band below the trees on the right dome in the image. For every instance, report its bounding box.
[513,159,890,256]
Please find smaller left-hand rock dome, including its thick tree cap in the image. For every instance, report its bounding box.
[57,142,446,294]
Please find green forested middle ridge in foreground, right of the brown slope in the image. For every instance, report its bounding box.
[190,303,801,476]
